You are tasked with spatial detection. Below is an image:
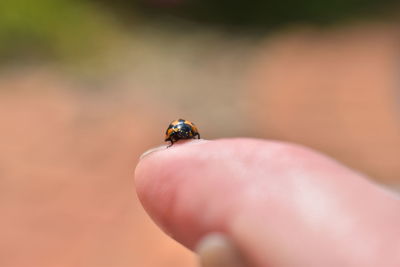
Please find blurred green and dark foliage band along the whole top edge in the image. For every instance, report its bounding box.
[0,0,396,65]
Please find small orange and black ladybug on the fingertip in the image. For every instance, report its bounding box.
[165,119,200,147]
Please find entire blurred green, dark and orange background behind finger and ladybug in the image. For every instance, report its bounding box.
[0,0,400,267]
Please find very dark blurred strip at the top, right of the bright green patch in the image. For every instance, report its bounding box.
[129,0,397,26]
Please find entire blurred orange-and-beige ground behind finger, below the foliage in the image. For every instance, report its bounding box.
[0,20,400,267]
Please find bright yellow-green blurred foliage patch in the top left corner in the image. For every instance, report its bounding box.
[0,0,116,64]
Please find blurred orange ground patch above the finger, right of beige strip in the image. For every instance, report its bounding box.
[251,24,400,184]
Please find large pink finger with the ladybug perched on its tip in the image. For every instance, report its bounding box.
[135,138,400,267]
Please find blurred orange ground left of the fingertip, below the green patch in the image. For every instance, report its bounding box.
[0,73,193,266]
